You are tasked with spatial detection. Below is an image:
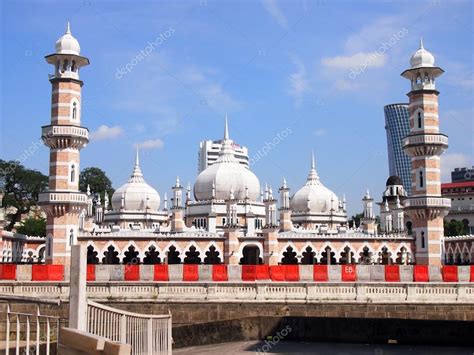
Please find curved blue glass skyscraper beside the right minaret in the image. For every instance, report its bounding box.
[384,104,411,194]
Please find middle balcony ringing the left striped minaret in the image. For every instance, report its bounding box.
[41,125,89,149]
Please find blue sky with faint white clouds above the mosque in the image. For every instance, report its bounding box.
[0,0,474,214]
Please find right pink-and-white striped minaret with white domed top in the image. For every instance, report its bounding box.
[401,41,451,265]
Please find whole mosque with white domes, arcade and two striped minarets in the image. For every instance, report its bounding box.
[31,24,450,264]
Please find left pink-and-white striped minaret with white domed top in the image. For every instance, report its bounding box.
[39,23,89,264]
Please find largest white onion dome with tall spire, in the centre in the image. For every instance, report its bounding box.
[194,116,260,201]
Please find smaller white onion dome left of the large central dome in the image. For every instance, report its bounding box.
[112,149,160,211]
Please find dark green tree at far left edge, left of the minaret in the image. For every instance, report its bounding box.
[0,159,48,231]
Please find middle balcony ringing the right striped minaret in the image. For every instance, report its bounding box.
[403,133,448,156]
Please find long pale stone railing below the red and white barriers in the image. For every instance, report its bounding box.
[0,281,474,304]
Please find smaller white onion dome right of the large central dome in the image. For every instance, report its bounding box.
[290,154,339,214]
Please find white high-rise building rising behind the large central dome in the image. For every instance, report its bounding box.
[198,118,249,174]
